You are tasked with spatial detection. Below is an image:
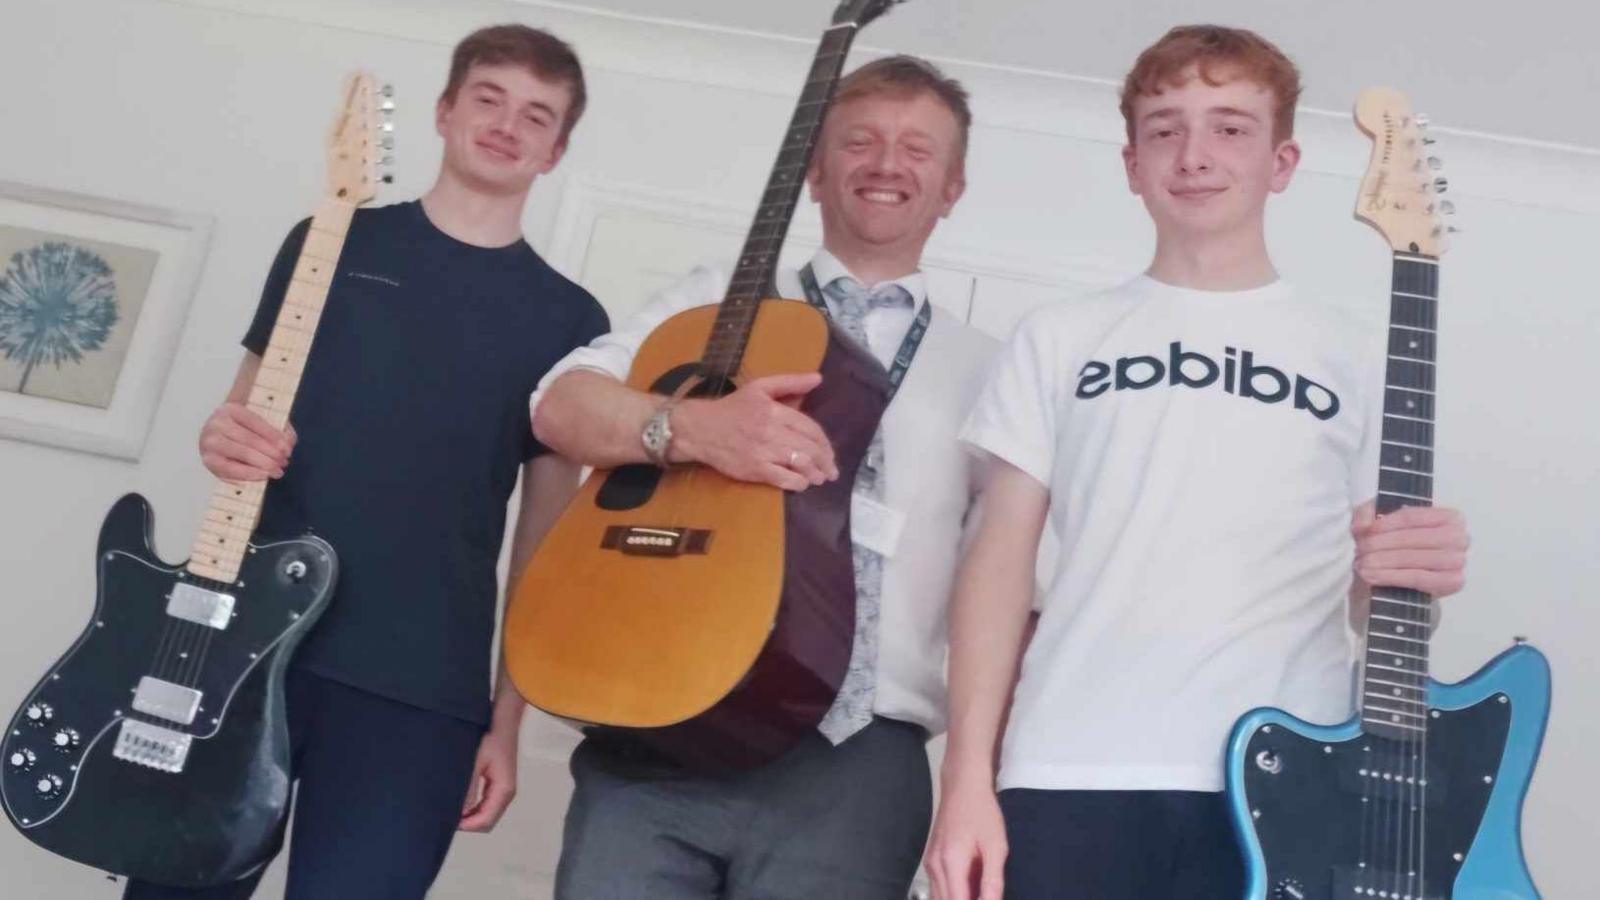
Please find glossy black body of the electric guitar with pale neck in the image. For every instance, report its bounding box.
[0,495,338,887]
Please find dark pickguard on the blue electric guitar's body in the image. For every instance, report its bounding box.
[1245,695,1510,900]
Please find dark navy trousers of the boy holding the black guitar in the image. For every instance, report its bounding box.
[123,668,483,900]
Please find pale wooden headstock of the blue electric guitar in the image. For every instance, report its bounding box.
[1355,88,1456,256]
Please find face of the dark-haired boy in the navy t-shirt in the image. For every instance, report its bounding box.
[435,66,571,194]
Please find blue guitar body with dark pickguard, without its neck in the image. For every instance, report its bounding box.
[1227,644,1550,900]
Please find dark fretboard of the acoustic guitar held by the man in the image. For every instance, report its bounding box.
[702,22,858,375]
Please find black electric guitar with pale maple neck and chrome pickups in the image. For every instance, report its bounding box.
[0,75,392,887]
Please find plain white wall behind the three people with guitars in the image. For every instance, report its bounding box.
[0,0,1600,900]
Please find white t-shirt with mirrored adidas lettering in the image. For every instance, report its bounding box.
[962,277,1382,791]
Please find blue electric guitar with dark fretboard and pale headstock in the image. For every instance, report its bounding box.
[1227,88,1550,900]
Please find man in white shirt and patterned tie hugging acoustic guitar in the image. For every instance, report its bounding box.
[533,56,997,900]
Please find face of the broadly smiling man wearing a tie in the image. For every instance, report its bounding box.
[808,91,966,271]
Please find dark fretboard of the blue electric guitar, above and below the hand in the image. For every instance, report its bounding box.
[1362,253,1438,741]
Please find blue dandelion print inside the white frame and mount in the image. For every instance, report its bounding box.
[0,227,157,408]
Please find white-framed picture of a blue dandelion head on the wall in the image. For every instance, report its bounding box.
[0,181,211,460]
